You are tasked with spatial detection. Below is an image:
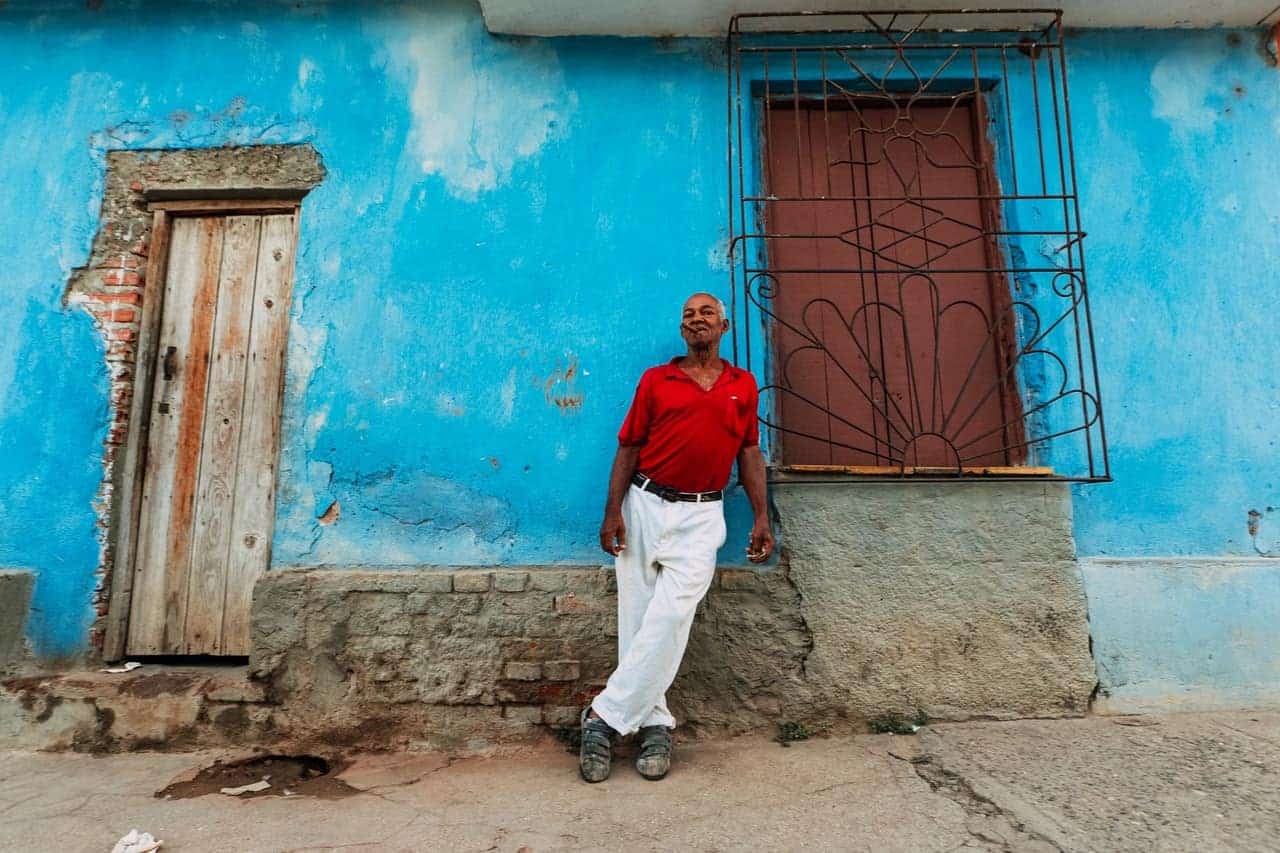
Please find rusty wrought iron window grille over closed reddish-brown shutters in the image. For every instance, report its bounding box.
[727,9,1111,482]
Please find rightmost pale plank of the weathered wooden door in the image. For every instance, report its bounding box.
[221,215,297,654]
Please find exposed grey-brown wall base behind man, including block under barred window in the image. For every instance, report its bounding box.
[250,483,1097,748]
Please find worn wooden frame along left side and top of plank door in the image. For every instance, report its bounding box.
[102,191,302,661]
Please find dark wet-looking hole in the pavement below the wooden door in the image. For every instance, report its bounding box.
[162,756,360,799]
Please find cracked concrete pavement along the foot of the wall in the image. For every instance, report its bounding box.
[0,712,1280,853]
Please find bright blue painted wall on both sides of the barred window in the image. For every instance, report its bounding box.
[0,3,1280,657]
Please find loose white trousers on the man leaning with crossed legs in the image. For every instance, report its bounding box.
[591,485,726,735]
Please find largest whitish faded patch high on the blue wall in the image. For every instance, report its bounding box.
[376,3,577,200]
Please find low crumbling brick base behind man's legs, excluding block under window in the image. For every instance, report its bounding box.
[250,567,809,748]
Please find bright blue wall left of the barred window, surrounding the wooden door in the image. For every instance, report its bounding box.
[0,4,745,656]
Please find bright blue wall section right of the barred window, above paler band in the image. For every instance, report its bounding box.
[1069,31,1280,555]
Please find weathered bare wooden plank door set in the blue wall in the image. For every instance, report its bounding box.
[127,213,296,656]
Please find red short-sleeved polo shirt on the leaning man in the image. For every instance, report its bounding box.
[618,357,760,492]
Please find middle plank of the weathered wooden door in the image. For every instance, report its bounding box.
[175,216,260,654]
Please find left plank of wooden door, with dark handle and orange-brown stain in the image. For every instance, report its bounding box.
[128,218,223,654]
